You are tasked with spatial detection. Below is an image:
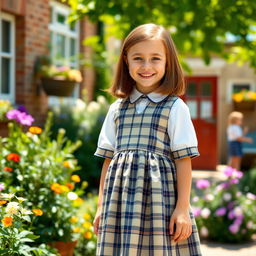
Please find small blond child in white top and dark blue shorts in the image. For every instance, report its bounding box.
[227,111,252,170]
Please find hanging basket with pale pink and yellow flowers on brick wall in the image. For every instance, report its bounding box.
[36,57,82,97]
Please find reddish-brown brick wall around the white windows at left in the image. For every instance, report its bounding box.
[0,0,96,135]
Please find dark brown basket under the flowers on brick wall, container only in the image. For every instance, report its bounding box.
[41,77,76,97]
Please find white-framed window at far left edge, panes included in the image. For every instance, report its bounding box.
[0,13,15,103]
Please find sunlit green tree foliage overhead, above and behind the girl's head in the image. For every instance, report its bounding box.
[63,0,256,68]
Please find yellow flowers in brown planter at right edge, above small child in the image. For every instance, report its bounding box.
[232,90,256,111]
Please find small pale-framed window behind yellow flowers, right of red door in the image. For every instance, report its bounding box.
[227,79,255,103]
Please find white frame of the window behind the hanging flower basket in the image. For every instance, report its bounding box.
[48,1,80,106]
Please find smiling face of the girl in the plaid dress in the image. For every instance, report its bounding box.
[126,39,166,93]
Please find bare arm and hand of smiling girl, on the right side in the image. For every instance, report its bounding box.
[170,157,192,242]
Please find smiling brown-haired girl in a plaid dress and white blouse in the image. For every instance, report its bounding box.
[93,24,201,256]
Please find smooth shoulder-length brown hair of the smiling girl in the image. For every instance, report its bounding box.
[108,24,185,98]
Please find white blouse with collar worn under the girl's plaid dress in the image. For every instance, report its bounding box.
[95,88,198,159]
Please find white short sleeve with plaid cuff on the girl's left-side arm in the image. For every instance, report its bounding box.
[94,102,116,158]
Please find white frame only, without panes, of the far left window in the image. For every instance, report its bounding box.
[0,12,15,104]
